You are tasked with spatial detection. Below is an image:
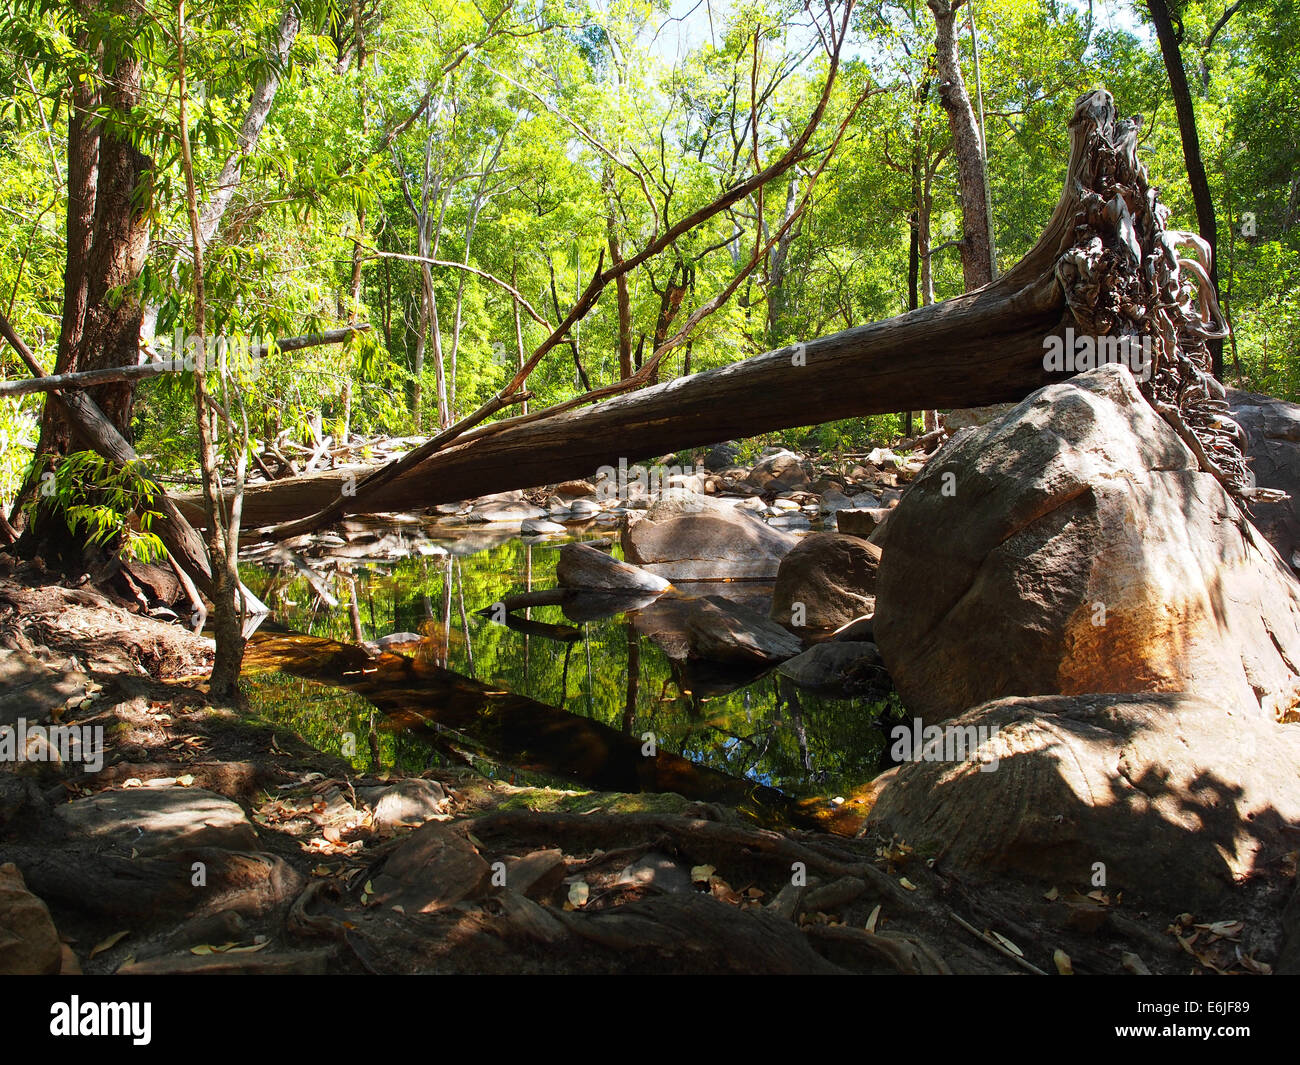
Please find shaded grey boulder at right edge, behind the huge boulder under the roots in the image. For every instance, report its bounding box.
[1227,389,1300,571]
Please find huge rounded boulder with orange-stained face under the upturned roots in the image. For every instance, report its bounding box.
[875,365,1300,720]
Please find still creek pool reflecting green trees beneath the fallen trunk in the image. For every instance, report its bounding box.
[241,528,888,798]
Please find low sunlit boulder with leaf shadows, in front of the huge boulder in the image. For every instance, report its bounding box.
[870,692,1300,914]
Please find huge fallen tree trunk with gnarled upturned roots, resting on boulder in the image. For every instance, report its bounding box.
[180,92,1245,536]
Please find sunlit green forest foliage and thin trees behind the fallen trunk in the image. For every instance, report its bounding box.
[0,0,1300,506]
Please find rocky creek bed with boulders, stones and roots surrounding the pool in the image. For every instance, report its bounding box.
[0,368,1300,973]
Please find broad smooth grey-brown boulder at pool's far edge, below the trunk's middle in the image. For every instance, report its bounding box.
[623,494,798,583]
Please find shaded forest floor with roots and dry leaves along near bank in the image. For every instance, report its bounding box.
[0,555,1258,973]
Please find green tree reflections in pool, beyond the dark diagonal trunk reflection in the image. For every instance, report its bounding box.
[244,540,883,792]
